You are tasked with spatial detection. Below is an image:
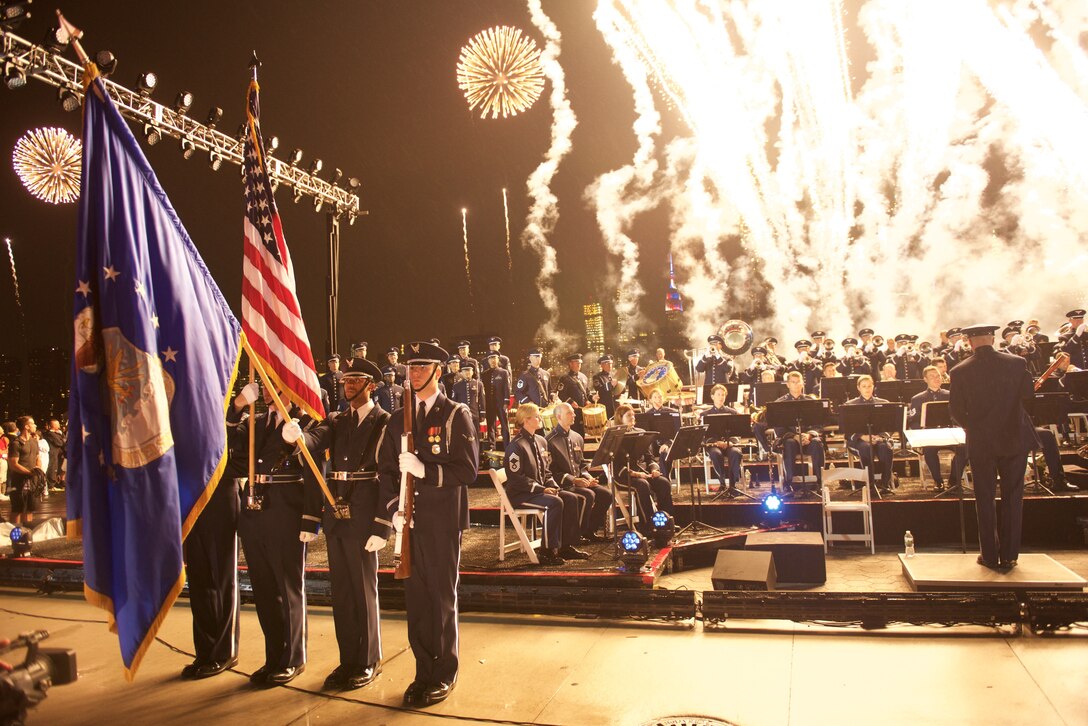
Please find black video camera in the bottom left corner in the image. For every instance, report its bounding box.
[0,630,77,726]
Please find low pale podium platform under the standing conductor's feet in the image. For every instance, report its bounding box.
[899,553,1088,592]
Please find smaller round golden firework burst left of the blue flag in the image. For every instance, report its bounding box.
[11,127,83,205]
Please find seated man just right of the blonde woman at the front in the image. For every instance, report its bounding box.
[547,403,613,542]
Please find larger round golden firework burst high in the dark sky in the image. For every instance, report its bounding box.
[457,25,544,119]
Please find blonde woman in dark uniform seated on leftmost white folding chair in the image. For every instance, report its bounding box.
[503,404,590,566]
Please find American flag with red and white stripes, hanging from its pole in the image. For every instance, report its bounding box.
[242,78,324,418]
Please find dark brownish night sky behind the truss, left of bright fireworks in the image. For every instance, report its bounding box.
[0,0,677,357]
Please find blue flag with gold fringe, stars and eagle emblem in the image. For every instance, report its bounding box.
[67,69,240,680]
